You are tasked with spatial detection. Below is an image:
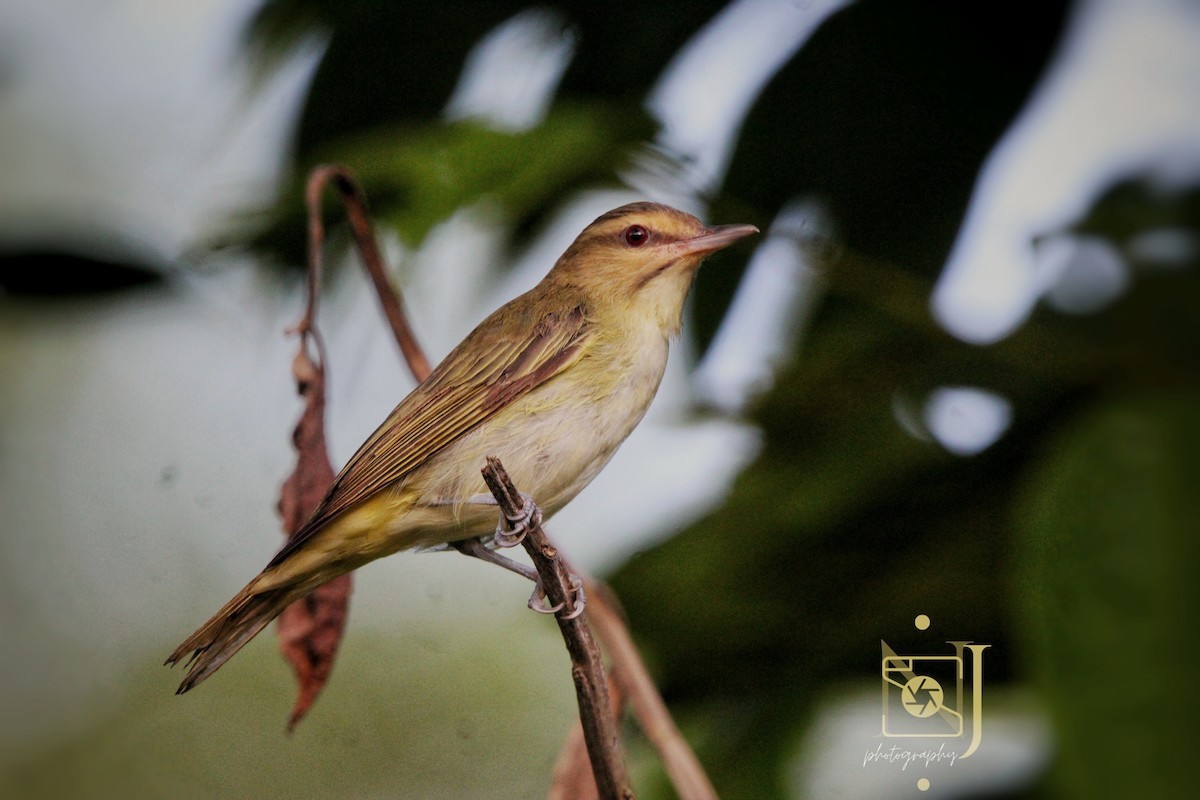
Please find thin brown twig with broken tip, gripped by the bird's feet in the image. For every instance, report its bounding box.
[482,456,634,800]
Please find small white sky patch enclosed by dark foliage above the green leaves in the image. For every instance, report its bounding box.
[446,8,575,132]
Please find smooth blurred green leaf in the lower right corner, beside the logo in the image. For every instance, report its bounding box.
[1012,391,1200,798]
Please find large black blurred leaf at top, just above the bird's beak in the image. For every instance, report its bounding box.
[725,1,1066,268]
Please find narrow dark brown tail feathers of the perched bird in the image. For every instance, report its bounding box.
[167,576,304,694]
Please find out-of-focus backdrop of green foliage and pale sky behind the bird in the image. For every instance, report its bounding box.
[0,0,1200,799]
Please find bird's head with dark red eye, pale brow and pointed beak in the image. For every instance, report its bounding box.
[550,203,758,333]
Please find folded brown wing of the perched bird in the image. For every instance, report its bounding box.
[269,307,592,566]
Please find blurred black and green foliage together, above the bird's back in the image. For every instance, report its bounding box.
[247,0,725,264]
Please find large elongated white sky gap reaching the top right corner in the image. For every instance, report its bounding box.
[932,0,1200,343]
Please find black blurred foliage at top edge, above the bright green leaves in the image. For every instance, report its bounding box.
[248,0,725,151]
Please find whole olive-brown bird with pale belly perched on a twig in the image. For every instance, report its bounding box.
[167,203,758,692]
